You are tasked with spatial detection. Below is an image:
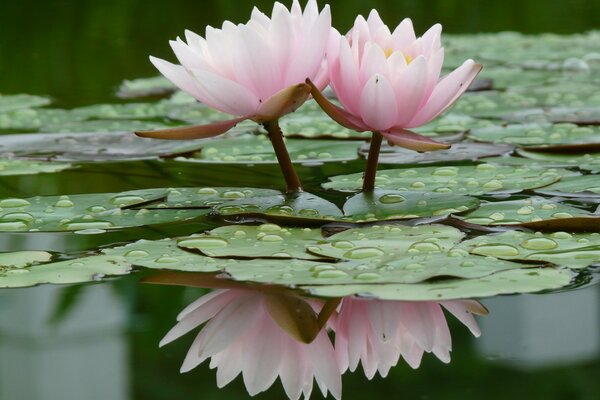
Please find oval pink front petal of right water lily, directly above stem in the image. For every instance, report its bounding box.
[360,74,398,131]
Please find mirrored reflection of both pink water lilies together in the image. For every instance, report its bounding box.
[160,288,486,399]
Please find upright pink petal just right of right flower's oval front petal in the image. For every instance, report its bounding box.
[393,56,428,124]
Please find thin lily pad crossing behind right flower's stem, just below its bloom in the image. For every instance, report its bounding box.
[370,142,514,164]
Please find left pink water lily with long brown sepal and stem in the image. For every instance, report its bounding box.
[136,0,334,190]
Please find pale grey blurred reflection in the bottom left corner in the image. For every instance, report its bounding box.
[0,285,129,400]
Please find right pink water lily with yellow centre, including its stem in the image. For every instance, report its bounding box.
[307,10,482,191]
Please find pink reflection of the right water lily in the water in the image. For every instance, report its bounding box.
[334,297,485,379]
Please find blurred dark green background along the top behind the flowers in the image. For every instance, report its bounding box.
[0,0,600,106]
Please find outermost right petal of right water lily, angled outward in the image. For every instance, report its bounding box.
[406,60,482,128]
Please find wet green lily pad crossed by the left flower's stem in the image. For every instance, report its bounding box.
[176,134,363,164]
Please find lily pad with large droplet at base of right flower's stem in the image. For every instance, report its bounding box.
[343,189,479,222]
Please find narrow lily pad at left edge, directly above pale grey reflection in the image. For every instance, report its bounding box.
[0,256,131,288]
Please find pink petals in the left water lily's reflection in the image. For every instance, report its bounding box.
[161,289,341,399]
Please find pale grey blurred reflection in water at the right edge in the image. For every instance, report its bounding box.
[478,286,600,369]
